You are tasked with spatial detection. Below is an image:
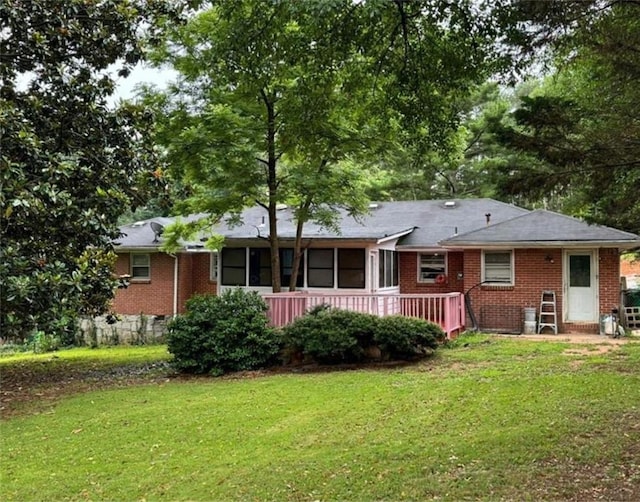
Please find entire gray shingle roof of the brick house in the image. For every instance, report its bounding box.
[116,199,640,250]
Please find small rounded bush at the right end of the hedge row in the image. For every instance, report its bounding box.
[374,315,445,359]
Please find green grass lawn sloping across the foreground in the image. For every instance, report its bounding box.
[0,335,640,501]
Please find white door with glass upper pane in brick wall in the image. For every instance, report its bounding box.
[565,250,598,322]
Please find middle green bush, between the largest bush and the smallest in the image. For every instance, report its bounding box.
[283,307,377,364]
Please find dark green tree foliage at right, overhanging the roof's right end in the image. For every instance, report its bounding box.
[482,1,640,233]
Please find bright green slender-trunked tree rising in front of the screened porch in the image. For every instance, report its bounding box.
[146,0,494,291]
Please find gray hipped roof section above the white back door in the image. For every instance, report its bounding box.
[440,210,640,247]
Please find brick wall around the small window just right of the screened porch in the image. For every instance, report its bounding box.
[399,252,464,294]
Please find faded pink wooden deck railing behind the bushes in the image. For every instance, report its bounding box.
[262,292,465,338]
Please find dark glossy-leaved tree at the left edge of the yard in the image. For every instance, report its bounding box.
[0,0,192,339]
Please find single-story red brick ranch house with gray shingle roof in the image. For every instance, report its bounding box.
[113,199,640,333]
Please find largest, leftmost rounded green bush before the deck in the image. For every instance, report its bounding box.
[167,289,280,375]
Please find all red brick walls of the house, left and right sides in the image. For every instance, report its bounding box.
[113,249,620,332]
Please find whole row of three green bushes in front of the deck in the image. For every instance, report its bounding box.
[167,289,444,375]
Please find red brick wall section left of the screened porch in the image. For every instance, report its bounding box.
[113,253,216,315]
